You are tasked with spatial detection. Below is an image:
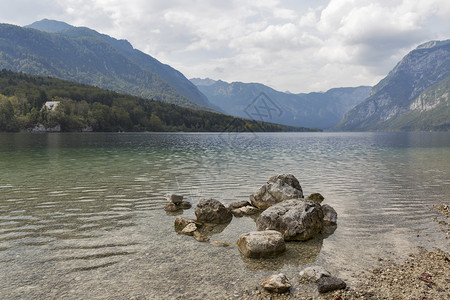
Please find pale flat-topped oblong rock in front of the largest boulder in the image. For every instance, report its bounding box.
[237,230,286,258]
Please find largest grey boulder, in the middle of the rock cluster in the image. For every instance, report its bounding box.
[256,199,323,241]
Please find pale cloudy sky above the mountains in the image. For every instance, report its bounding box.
[0,0,450,93]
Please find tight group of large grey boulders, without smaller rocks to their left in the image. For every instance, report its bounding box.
[238,174,337,257]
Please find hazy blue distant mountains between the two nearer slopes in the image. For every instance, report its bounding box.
[191,78,370,129]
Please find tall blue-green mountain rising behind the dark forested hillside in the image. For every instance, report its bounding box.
[0,19,212,110]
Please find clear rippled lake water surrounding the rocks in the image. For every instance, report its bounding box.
[0,133,450,299]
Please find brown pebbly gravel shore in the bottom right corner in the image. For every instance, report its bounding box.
[222,204,450,300]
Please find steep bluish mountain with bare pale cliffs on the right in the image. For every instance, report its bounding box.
[335,40,450,131]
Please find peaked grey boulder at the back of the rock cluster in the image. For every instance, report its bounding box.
[250,174,303,209]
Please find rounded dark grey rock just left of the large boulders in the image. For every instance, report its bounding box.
[195,199,233,224]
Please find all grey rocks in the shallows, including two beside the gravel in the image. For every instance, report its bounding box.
[164,174,345,293]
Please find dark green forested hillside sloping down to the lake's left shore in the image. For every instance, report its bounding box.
[0,70,318,132]
